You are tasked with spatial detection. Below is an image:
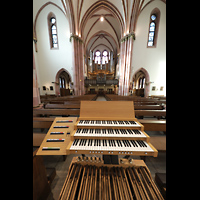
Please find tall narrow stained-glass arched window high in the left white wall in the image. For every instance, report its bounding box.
[47,13,58,49]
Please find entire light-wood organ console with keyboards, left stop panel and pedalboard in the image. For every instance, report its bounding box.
[37,101,163,200]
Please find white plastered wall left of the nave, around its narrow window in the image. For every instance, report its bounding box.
[33,4,73,95]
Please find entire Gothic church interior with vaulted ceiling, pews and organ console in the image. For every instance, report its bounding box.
[33,0,166,200]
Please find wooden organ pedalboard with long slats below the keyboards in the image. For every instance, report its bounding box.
[59,157,164,200]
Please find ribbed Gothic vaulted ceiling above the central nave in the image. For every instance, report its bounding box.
[61,0,166,54]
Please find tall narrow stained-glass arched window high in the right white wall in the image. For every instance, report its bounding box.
[147,8,160,47]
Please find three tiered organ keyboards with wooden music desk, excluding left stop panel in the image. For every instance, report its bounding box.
[66,101,158,157]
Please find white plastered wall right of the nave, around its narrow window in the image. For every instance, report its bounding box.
[130,0,166,95]
